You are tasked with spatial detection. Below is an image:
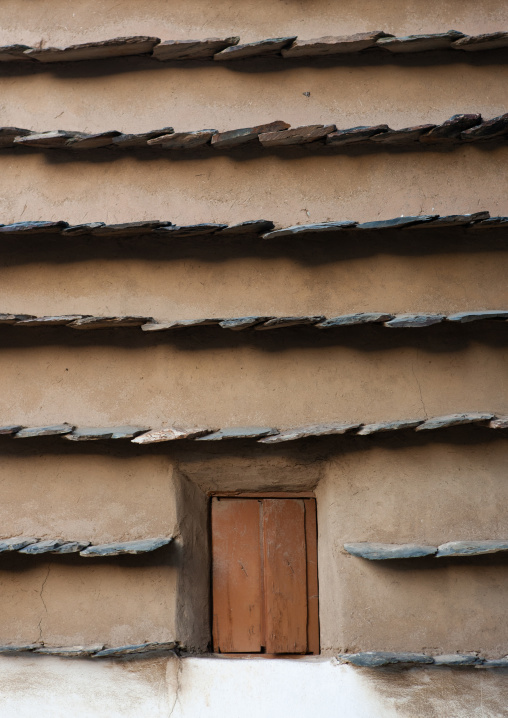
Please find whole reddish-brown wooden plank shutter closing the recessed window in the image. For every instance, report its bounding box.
[212,498,319,654]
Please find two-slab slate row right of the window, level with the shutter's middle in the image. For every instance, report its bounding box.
[344,541,508,561]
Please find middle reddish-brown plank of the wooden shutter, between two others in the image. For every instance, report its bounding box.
[263,499,307,653]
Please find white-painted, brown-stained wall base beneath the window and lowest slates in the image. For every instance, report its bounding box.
[0,656,508,718]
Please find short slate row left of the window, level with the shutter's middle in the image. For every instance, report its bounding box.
[0,536,173,557]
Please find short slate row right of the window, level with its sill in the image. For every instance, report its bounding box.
[338,651,508,668]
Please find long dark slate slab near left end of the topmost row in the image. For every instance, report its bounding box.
[26,35,160,62]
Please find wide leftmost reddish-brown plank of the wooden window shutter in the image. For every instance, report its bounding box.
[212,498,262,653]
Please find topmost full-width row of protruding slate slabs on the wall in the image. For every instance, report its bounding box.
[0,30,508,64]
